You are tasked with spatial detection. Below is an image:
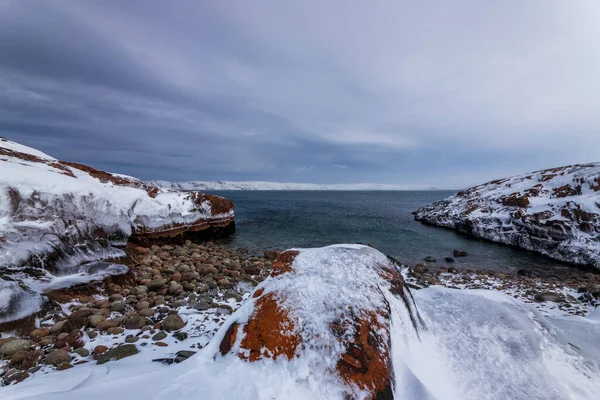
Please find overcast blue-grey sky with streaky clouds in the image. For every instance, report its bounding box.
[0,0,600,188]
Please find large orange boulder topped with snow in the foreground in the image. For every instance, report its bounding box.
[218,245,421,399]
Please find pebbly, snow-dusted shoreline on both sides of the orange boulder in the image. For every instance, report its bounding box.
[0,241,600,385]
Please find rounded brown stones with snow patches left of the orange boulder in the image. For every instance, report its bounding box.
[0,241,278,385]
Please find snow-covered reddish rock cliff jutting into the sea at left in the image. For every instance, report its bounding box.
[0,138,235,270]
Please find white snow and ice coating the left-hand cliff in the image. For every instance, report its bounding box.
[0,139,233,322]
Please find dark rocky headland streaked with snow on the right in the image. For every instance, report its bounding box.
[414,163,600,267]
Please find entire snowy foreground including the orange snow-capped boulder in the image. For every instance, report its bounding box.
[0,245,600,400]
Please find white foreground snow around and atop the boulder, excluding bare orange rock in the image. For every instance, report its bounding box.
[0,245,600,400]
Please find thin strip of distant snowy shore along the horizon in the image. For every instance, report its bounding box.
[148,181,454,191]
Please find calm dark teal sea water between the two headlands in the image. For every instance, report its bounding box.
[213,191,569,272]
